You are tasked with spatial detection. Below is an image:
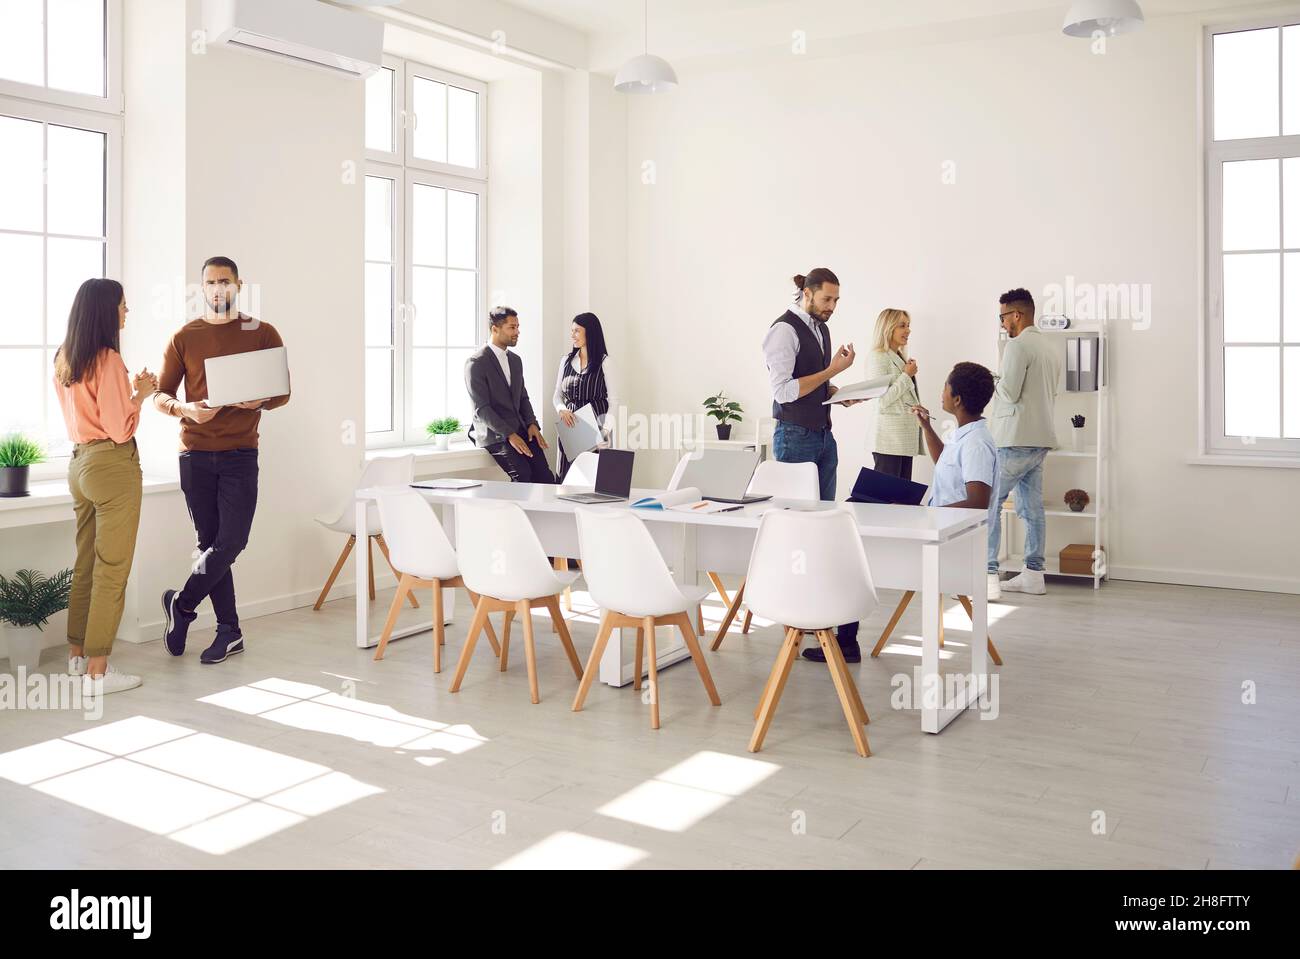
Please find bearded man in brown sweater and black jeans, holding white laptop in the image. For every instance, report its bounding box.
[153,256,289,663]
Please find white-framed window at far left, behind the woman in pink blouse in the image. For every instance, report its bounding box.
[0,0,122,469]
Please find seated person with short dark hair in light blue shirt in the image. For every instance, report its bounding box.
[911,363,997,509]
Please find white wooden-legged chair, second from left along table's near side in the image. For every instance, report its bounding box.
[451,500,582,703]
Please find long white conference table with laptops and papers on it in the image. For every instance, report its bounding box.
[354,480,988,733]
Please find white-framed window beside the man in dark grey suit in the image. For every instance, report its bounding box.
[365,57,488,447]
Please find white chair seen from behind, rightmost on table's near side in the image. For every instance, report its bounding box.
[746,509,878,756]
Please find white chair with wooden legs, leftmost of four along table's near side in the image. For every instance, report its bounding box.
[374,487,501,673]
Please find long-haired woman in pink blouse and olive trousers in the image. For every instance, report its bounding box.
[55,279,157,697]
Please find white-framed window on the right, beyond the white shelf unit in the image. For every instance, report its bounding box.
[1205,16,1300,457]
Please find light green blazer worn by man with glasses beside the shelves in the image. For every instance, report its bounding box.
[988,326,1061,450]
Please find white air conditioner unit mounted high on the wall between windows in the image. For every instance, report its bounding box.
[203,0,384,78]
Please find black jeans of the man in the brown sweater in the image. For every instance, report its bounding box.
[179,448,257,632]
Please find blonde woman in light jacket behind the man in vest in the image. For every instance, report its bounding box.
[867,309,924,480]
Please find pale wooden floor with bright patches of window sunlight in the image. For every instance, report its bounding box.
[0,581,1300,869]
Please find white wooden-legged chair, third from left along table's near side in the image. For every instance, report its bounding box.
[573,507,722,729]
